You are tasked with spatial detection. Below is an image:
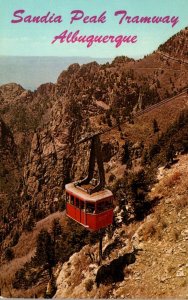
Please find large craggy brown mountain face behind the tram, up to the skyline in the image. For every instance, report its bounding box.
[0,29,187,220]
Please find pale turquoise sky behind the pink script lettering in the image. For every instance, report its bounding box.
[0,0,188,58]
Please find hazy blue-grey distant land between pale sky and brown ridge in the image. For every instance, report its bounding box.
[0,56,111,91]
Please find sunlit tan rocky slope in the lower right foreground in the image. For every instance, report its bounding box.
[55,155,188,298]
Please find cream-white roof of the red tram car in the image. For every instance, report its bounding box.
[65,182,113,202]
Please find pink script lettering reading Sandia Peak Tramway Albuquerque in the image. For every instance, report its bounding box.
[11,9,179,48]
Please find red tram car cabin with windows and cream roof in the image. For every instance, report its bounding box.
[65,183,113,231]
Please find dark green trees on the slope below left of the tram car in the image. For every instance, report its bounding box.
[13,219,98,289]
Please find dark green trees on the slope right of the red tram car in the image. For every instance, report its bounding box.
[112,110,188,223]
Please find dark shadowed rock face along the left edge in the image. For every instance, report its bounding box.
[0,119,22,243]
